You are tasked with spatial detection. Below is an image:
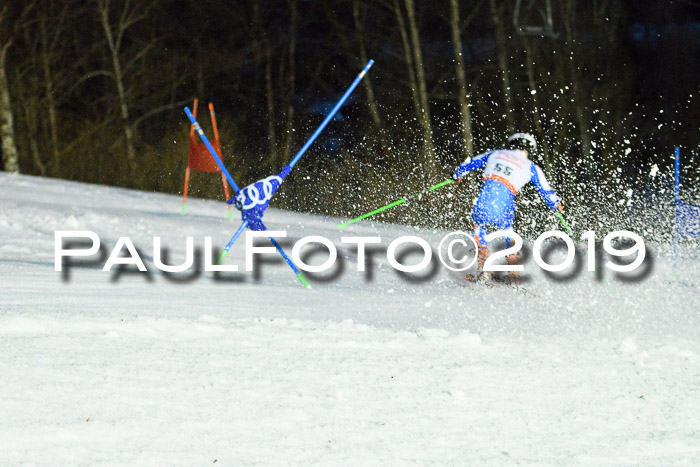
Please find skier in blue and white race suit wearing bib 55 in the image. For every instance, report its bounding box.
[452,133,562,280]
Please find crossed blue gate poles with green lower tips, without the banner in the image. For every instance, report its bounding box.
[185,60,374,288]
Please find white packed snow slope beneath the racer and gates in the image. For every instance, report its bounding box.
[0,173,700,465]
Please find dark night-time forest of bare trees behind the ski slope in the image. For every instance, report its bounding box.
[0,0,700,234]
